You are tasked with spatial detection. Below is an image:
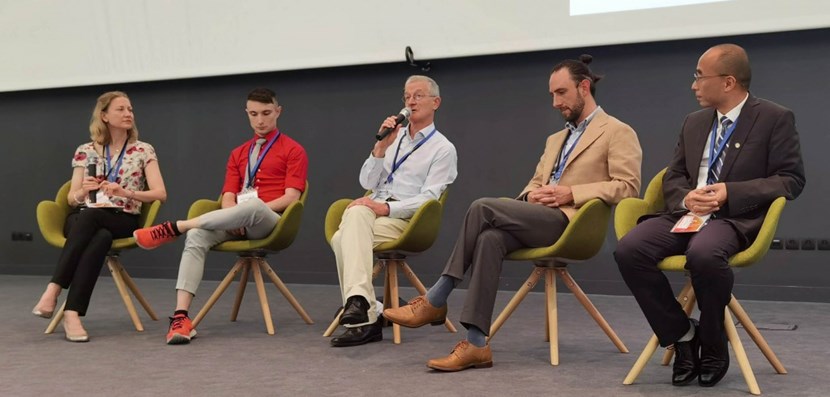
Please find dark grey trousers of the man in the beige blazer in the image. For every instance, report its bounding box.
[444,198,568,335]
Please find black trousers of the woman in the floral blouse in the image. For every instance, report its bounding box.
[52,208,138,316]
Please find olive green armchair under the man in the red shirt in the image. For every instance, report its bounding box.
[187,182,314,335]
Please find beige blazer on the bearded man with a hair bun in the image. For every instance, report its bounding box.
[519,109,643,219]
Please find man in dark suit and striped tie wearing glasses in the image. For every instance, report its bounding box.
[614,44,805,387]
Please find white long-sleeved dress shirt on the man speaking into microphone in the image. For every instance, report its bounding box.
[360,123,458,219]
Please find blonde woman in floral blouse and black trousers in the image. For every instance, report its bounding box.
[32,91,167,342]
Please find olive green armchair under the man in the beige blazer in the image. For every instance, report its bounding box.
[489,199,628,365]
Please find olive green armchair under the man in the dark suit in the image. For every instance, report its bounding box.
[614,169,787,395]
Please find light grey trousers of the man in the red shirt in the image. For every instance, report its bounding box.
[176,199,280,295]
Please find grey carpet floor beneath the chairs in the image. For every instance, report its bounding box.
[0,275,830,396]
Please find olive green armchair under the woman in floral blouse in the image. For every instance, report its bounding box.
[37,182,161,334]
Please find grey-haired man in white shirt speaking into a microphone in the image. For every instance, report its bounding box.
[331,75,458,347]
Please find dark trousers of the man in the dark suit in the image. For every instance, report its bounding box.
[614,216,743,347]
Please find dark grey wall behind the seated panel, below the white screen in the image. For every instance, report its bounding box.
[0,29,830,304]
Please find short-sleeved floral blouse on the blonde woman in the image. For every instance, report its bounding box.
[72,141,158,215]
